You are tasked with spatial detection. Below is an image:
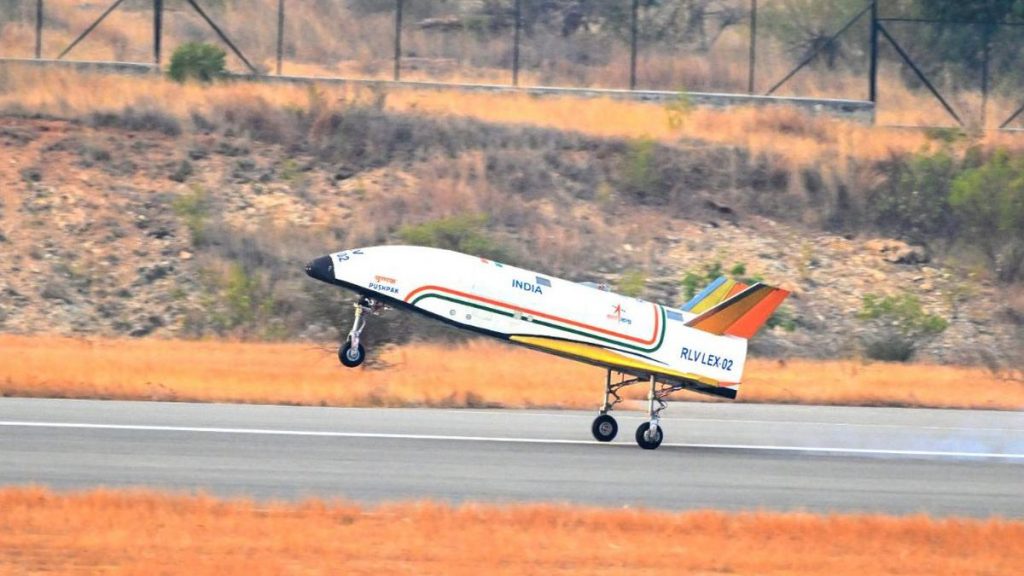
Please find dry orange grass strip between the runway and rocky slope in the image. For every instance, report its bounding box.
[0,335,1024,410]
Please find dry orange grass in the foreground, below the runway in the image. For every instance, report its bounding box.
[0,488,1024,576]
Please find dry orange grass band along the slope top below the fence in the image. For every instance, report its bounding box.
[8,65,1024,169]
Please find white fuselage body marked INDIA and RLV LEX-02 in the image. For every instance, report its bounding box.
[317,246,746,384]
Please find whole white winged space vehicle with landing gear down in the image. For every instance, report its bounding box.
[306,246,788,450]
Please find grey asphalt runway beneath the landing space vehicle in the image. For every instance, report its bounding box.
[0,398,1024,518]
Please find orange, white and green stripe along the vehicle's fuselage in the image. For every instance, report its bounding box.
[406,286,665,353]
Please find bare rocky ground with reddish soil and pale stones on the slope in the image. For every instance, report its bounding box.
[0,118,1022,366]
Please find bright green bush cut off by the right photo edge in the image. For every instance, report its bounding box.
[949,150,1024,282]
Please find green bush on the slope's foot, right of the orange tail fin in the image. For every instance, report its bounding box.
[857,293,949,362]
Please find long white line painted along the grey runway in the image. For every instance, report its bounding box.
[6,420,1024,460]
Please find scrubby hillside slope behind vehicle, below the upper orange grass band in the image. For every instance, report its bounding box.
[0,100,1020,366]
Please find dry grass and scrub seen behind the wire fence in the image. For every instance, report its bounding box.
[0,0,1018,125]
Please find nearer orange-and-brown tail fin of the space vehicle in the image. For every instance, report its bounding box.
[686,282,790,339]
